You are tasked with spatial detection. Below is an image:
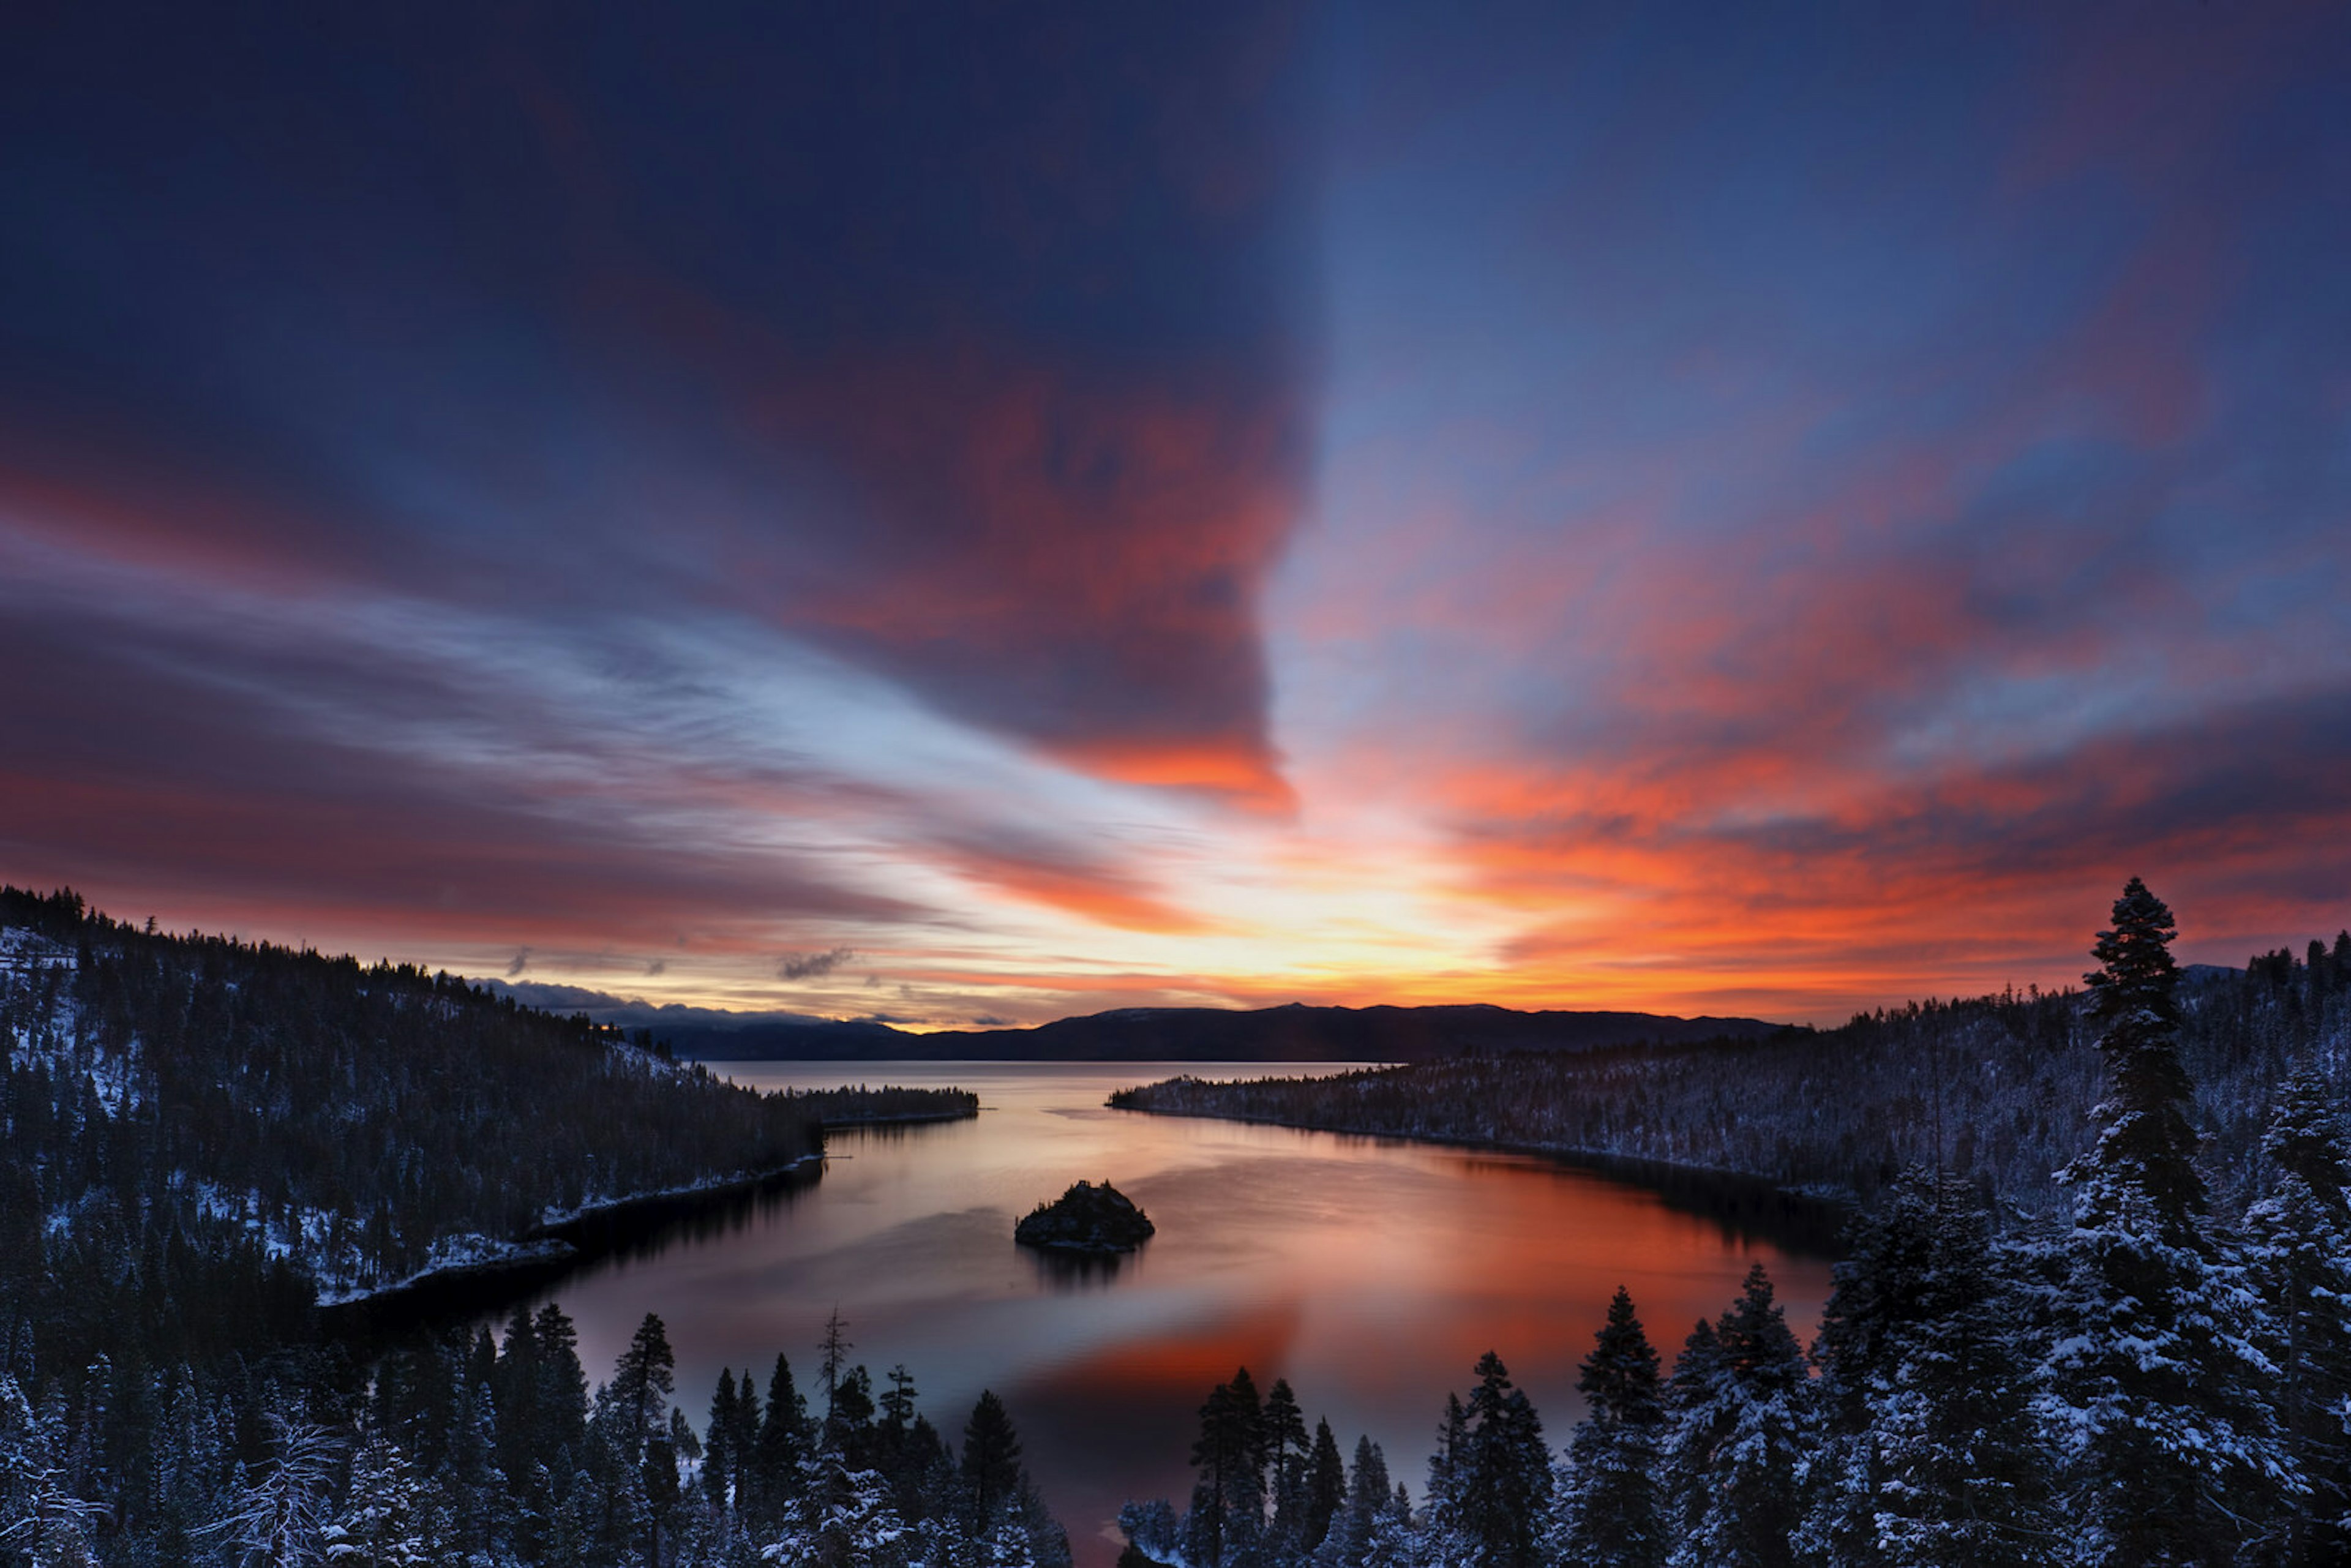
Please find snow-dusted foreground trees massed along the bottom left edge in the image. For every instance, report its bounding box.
[0,1305,1070,1568]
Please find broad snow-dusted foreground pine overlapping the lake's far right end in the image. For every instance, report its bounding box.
[1667,1262,1813,1568]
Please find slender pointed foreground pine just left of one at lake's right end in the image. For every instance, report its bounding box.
[1559,1286,1665,1568]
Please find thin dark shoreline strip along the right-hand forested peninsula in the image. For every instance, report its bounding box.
[1109,1105,1859,1258]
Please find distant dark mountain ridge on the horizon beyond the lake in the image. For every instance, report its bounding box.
[625,1004,1782,1062]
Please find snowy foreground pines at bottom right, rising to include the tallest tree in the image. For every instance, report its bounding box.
[1122,879,2351,1568]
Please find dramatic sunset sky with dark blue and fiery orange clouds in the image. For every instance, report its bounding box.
[0,0,2351,1027]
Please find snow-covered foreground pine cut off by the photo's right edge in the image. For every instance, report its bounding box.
[2245,1062,2351,1563]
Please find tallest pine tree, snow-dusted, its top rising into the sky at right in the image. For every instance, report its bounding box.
[2041,877,2301,1568]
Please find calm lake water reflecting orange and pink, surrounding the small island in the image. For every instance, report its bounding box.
[510,1062,1829,1568]
